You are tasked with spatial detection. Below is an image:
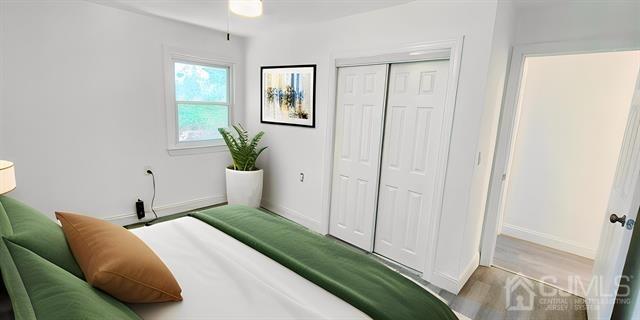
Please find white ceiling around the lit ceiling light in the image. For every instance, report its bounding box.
[95,0,411,36]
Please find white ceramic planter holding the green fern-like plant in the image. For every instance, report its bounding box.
[226,168,263,208]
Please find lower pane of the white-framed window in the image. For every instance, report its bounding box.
[178,104,229,142]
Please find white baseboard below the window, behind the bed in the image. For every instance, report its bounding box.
[105,195,227,225]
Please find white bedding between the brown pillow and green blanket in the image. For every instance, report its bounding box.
[130,217,370,319]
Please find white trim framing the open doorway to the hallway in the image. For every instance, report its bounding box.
[480,39,640,266]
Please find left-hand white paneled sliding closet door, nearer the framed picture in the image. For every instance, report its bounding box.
[329,65,387,251]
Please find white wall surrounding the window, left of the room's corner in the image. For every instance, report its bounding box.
[0,1,245,224]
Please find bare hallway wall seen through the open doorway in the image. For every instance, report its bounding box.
[502,51,640,258]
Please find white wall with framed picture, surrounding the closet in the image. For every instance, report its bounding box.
[246,1,496,290]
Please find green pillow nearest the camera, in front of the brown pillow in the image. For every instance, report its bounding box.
[3,239,140,320]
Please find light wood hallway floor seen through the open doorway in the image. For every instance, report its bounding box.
[493,235,593,296]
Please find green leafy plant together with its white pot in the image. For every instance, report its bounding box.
[218,124,267,208]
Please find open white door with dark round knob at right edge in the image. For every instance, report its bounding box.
[586,70,640,319]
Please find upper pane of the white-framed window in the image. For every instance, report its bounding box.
[174,62,229,102]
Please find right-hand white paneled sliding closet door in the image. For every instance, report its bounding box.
[374,60,449,271]
